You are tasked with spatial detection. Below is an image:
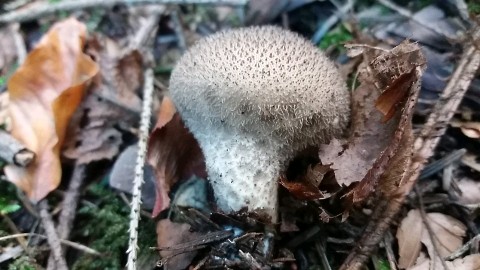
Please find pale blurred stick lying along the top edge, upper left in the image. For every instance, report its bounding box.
[0,0,248,24]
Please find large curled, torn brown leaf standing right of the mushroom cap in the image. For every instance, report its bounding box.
[319,41,425,202]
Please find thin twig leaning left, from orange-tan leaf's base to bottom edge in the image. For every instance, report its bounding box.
[38,199,68,270]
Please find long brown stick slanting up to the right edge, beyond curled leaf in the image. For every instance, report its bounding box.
[340,41,480,270]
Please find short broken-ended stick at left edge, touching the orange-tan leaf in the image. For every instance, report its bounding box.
[0,129,35,167]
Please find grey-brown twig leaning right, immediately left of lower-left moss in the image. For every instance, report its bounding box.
[47,164,86,269]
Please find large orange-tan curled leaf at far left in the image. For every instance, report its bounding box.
[5,19,98,201]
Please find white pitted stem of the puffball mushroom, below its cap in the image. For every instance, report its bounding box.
[196,129,284,223]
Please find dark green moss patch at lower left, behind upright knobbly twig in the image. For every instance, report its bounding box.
[72,184,156,270]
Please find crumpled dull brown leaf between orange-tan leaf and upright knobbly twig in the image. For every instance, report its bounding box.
[63,34,143,163]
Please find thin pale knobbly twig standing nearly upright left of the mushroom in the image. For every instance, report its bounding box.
[127,68,154,270]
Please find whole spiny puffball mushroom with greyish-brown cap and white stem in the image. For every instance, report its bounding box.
[170,26,350,222]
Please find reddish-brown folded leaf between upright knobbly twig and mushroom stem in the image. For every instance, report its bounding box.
[148,97,206,216]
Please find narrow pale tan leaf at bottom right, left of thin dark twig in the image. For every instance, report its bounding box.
[397,210,424,269]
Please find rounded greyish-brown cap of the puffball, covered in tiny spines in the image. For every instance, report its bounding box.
[170,26,350,148]
